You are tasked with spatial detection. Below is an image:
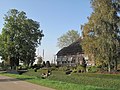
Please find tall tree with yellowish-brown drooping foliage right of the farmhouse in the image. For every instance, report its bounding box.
[82,0,120,72]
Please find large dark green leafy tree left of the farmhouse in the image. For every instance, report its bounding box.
[0,9,44,67]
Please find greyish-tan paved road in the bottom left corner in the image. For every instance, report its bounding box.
[0,76,53,90]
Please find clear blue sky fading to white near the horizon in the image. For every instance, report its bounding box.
[0,0,92,61]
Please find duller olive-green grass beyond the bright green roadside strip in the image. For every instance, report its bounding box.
[20,70,120,90]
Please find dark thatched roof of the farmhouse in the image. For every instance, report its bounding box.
[57,39,83,56]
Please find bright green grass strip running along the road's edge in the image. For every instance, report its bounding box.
[2,74,112,90]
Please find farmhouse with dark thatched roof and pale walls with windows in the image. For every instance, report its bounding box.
[57,39,94,66]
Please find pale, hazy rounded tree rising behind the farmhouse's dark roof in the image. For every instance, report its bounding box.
[58,30,80,48]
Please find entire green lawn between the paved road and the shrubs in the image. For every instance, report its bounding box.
[2,70,120,90]
